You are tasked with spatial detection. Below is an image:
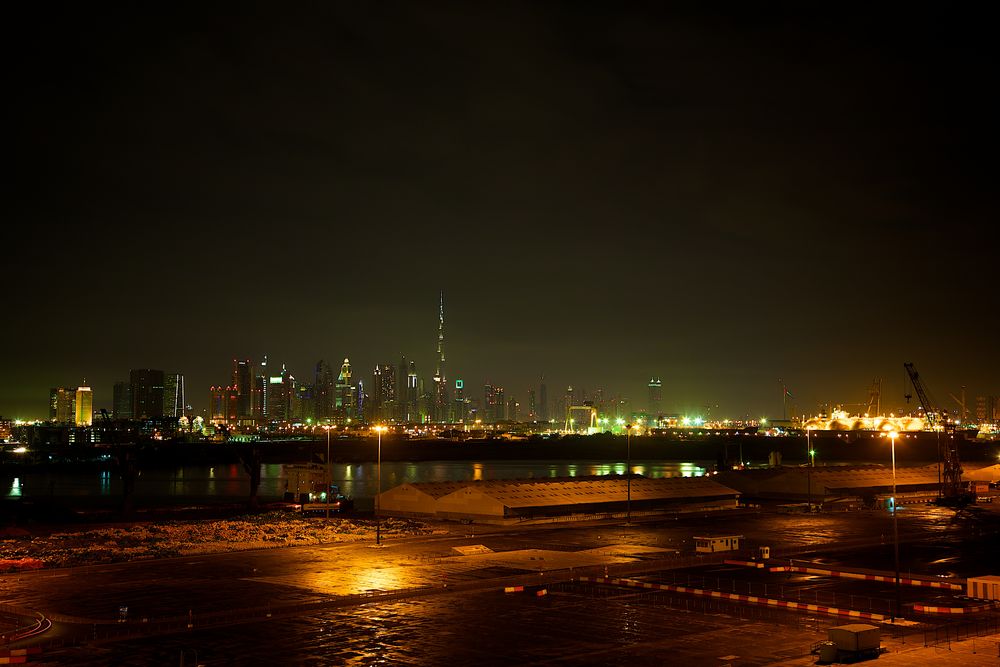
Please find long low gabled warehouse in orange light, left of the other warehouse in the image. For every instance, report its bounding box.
[379,475,740,521]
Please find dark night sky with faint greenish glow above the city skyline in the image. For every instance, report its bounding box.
[0,2,1000,417]
